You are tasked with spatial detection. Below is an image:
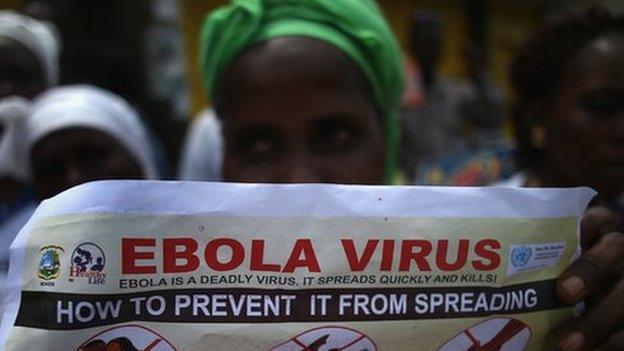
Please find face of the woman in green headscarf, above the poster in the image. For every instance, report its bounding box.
[219,37,383,184]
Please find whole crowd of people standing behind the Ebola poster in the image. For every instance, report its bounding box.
[0,0,624,278]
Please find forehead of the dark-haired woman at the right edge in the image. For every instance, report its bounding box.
[562,35,624,89]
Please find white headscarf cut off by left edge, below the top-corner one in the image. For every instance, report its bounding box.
[0,96,29,180]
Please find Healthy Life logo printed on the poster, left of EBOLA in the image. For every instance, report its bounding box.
[69,243,107,285]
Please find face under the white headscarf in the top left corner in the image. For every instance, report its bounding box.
[0,37,46,99]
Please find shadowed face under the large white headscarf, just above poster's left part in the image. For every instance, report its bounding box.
[31,128,145,200]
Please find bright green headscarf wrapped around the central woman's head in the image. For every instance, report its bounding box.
[200,0,404,183]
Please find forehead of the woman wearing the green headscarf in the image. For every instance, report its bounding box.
[220,37,373,123]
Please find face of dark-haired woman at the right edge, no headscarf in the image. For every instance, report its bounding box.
[544,35,624,200]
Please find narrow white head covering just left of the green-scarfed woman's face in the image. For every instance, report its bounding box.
[178,108,223,181]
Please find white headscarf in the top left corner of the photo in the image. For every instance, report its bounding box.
[0,11,60,87]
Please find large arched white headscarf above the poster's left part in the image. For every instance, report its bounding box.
[25,85,158,179]
